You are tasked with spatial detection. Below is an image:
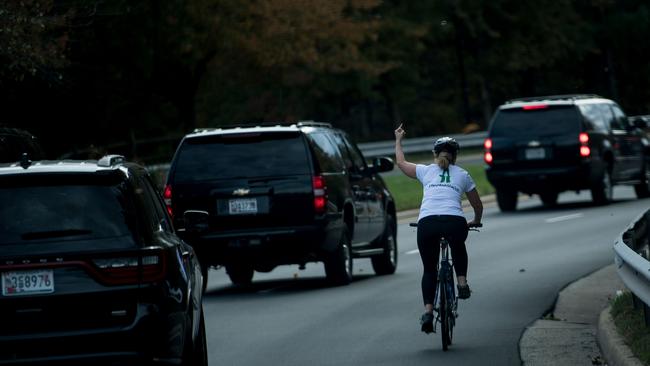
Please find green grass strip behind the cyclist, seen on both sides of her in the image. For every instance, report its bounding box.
[384,164,494,211]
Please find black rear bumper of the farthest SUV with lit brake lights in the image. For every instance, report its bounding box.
[485,161,604,194]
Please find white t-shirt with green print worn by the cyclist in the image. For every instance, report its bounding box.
[415,164,476,220]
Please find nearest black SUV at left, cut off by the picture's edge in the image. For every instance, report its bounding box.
[0,156,207,365]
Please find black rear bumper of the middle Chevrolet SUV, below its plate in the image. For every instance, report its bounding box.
[184,220,344,268]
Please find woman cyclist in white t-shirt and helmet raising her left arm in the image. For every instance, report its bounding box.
[395,124,483,333]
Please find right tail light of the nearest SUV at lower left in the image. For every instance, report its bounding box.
[92,251,167,285]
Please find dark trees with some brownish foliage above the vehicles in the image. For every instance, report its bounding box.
[0,0,650,163]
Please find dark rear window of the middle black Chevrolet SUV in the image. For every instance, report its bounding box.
[173,132,311,183]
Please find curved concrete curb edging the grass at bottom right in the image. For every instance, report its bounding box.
[597,306,643,366]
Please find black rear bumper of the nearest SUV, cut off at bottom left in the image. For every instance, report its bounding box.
[0,304,186,365]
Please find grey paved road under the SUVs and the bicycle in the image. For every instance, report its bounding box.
[204,187,650,365]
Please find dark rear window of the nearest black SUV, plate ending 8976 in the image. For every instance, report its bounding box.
[0,179,133,246]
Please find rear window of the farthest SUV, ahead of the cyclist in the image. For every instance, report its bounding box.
[491,106,580,138]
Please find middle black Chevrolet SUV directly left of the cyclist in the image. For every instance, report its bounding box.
[164,122,397,284]
